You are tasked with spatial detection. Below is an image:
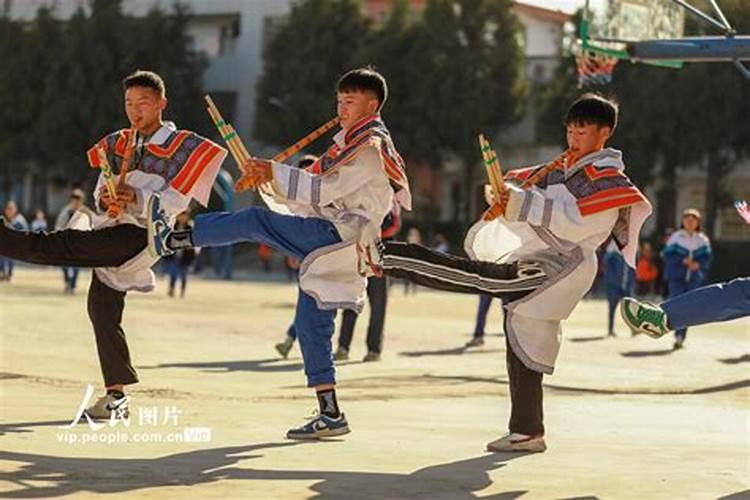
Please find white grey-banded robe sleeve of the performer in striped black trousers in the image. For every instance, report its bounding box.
[505,184,618,243]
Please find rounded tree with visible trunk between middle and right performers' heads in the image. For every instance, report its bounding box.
[406,0,525,223]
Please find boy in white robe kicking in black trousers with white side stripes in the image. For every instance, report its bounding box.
[381,94,651,452]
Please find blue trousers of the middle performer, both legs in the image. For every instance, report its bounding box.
[193,207,341,387]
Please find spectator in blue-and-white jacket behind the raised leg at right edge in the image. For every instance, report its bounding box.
[661,208,711,349]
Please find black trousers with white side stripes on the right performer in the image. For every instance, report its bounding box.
[383,242,546,434]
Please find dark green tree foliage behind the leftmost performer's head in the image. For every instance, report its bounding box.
[0,0,210,205]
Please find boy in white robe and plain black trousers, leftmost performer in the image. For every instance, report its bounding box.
[0,71,226,419]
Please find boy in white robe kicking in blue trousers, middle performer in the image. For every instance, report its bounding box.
[149,68,411,439]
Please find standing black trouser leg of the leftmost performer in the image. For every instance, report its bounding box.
[88,272,138,387]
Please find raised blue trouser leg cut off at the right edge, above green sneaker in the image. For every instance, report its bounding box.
[661,278,750,331]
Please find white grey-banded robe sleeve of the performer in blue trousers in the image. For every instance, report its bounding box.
[273,147,385,206]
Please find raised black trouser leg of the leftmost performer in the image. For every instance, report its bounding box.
[0,224,147,267]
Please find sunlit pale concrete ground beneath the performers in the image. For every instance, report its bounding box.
[0,267,750,499]
